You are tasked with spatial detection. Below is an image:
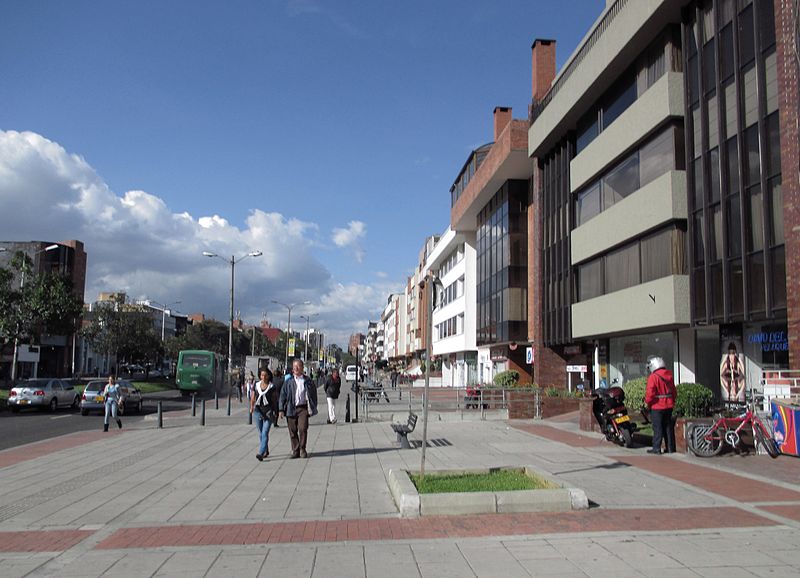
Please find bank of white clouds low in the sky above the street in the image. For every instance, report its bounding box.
[0,131,391,344]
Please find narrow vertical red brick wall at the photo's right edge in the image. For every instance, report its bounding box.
[774,0,800,369]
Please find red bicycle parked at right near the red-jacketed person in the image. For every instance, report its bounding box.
[687,407,781,458]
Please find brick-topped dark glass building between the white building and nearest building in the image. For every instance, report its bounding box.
[450,107,531,382]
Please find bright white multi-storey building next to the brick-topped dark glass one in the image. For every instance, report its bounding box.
[425,227,478,387]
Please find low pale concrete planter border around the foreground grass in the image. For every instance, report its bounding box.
[389,466,589,518]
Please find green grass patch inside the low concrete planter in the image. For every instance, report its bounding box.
[410,470,557,494]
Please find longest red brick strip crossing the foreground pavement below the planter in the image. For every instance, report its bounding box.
[96,507,777,550]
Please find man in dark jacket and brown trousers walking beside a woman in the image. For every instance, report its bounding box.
[279,359,317,459]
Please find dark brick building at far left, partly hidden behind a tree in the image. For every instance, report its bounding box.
[0,240,86,377]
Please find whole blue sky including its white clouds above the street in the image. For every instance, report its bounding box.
[0,0,605,341]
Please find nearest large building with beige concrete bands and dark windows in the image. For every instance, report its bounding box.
[528,0,800,391]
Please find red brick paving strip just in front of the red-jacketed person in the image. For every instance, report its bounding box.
[613,456,800,502]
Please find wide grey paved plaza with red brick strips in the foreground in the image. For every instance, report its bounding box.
[0,392,800,578]
